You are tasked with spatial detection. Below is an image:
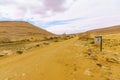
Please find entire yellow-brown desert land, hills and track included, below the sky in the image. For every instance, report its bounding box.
[0,21,120,80]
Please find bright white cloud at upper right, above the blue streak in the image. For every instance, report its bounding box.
[45,0,120,21]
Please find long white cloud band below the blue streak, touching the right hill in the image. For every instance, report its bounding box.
[45,16,120,34]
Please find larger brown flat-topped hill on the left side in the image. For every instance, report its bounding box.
[0,21,53,40]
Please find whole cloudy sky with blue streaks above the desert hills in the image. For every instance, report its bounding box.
[0,0,120,34]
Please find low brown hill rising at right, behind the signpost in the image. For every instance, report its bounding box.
[87,25,120,34]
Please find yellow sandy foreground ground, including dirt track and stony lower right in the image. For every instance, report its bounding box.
[0,38,120,80]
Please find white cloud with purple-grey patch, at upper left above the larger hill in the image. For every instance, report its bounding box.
[0,0,74,19]
